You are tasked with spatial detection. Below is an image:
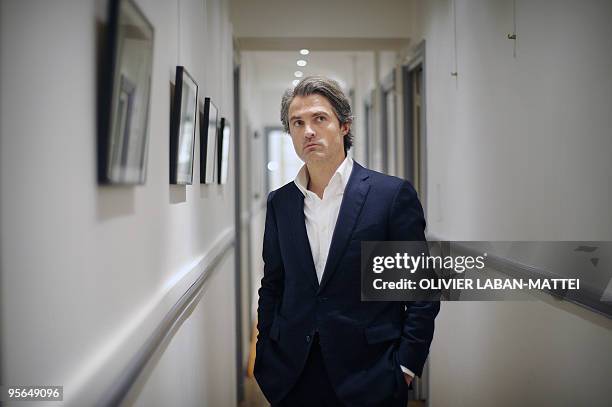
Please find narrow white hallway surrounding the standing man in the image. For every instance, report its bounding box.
[0,0,612,407]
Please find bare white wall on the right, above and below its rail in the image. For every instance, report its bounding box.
[422,0,612,407]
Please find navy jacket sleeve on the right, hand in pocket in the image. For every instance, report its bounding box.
[389,181,440,376]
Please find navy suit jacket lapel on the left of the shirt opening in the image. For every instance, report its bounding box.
[287,185,319,290]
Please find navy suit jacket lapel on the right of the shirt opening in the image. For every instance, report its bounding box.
[318,162,370,292]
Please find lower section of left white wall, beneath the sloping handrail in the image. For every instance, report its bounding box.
[134,255,237,407]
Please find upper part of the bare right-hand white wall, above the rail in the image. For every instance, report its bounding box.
[425,0,612,240]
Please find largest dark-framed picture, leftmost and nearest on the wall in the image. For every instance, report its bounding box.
[97,0,154,184]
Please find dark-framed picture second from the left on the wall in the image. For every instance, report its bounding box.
[170,66,198,185]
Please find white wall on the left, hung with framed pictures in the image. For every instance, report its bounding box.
[0,0,235,405]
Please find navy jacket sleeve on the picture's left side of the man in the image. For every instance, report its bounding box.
[257,192,284,342]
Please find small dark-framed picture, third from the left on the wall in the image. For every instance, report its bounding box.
[200,98,219,184]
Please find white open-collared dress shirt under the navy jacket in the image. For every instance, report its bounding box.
[294,157,414,377]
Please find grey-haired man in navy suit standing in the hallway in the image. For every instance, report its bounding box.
[254,77,440,407]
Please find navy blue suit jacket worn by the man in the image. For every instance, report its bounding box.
[254,162,440,406]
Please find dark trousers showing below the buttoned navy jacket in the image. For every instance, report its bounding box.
[272,334,408,407]
